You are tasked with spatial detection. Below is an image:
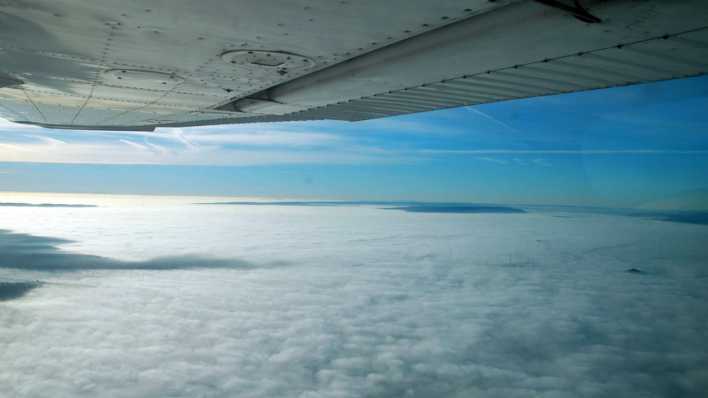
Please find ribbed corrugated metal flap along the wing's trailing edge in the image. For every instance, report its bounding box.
[266,29,708,121]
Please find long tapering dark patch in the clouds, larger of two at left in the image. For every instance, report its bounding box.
[0,230,255,271]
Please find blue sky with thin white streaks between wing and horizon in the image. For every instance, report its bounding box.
[0,73,708,208]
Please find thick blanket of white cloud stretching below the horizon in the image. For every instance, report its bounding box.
[0,206,708,398]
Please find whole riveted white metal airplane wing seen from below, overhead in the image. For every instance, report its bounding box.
[0,0,708,130]
